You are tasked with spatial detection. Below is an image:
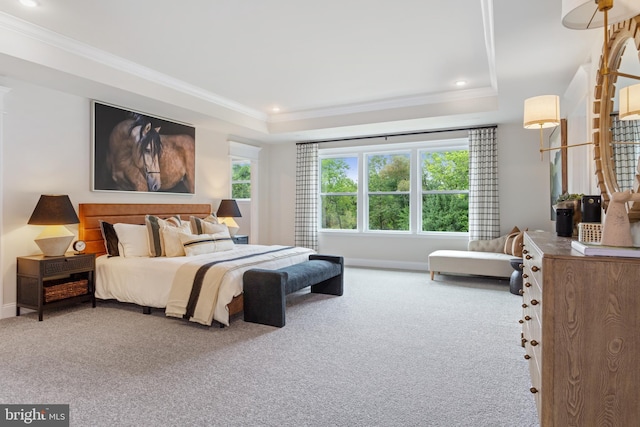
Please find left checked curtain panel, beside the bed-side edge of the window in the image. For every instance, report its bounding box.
[295,143,318,250]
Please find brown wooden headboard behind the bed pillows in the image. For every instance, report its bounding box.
[78,203,211,255]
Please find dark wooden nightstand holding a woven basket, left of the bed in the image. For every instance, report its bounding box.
[16,252,96,321]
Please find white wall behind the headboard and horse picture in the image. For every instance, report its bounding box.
[0,79,240,317]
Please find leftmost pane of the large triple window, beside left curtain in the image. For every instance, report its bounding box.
[320,157,358,230]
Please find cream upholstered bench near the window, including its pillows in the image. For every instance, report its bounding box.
[429,234,519,280]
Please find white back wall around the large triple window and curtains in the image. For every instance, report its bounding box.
[263,124,553,270]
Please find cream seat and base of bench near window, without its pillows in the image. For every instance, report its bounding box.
[429,250,514,280]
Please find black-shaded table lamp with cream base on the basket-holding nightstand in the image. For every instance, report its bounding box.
[28,195,80,256]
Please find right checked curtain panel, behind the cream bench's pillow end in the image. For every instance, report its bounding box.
[469,127,500,240]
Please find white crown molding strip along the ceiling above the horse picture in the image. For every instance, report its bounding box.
[0,12,268,121]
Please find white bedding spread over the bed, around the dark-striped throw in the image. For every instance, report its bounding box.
[95,245,315,325]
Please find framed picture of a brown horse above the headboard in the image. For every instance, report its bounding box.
[92,101,196,194]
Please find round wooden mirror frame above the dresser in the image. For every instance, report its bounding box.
[593,15,640,220]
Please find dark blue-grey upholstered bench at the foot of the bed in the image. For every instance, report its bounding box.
[243,255,344,328]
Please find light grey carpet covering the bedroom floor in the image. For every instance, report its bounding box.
[0,268,538,427]
